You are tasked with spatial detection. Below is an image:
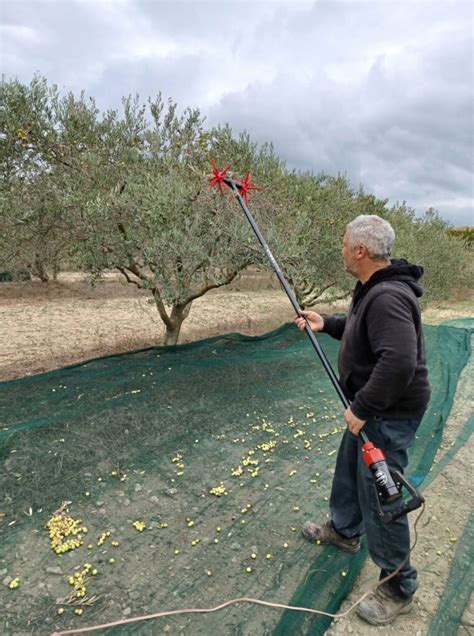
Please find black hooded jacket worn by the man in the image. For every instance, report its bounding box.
[323,259,430,420]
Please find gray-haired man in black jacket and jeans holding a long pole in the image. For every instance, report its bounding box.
[296,215,430,625]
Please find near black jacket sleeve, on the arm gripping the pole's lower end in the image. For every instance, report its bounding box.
[351,293,417,419]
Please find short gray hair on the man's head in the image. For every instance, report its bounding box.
[346,214,395,261]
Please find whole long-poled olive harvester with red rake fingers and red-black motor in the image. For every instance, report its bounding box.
[217,169,424,523]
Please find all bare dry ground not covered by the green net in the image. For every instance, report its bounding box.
[0,273,474,636]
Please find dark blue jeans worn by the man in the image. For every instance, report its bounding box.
[330,417,422,598]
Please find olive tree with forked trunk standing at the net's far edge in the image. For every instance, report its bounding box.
[71,96,280,344]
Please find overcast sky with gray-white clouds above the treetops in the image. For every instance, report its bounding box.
[0,0,474,225]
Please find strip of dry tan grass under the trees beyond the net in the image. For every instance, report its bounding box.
[0,270,474,380]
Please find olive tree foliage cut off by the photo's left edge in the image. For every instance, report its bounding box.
[0,75,102,281]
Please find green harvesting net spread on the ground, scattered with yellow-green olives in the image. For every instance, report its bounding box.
[0,325,470,635]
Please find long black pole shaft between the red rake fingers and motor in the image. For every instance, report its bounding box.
[224,178,369,443]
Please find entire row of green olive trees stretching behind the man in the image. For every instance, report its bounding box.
[0,75,467,344]
